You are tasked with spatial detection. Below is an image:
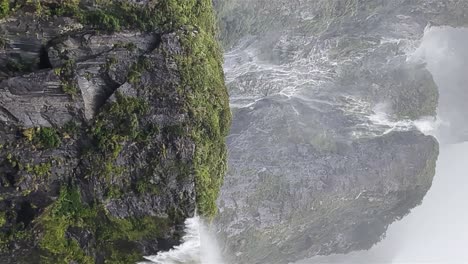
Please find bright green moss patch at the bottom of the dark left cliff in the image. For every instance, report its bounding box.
[39,187,172,263]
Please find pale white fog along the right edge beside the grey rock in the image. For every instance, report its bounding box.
[298,27,468,264]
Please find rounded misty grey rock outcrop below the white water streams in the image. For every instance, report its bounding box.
[217,99,438,263]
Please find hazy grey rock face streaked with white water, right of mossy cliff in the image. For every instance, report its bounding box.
[215,0,468,263]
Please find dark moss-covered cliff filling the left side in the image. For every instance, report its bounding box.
[0,0,230,263]
